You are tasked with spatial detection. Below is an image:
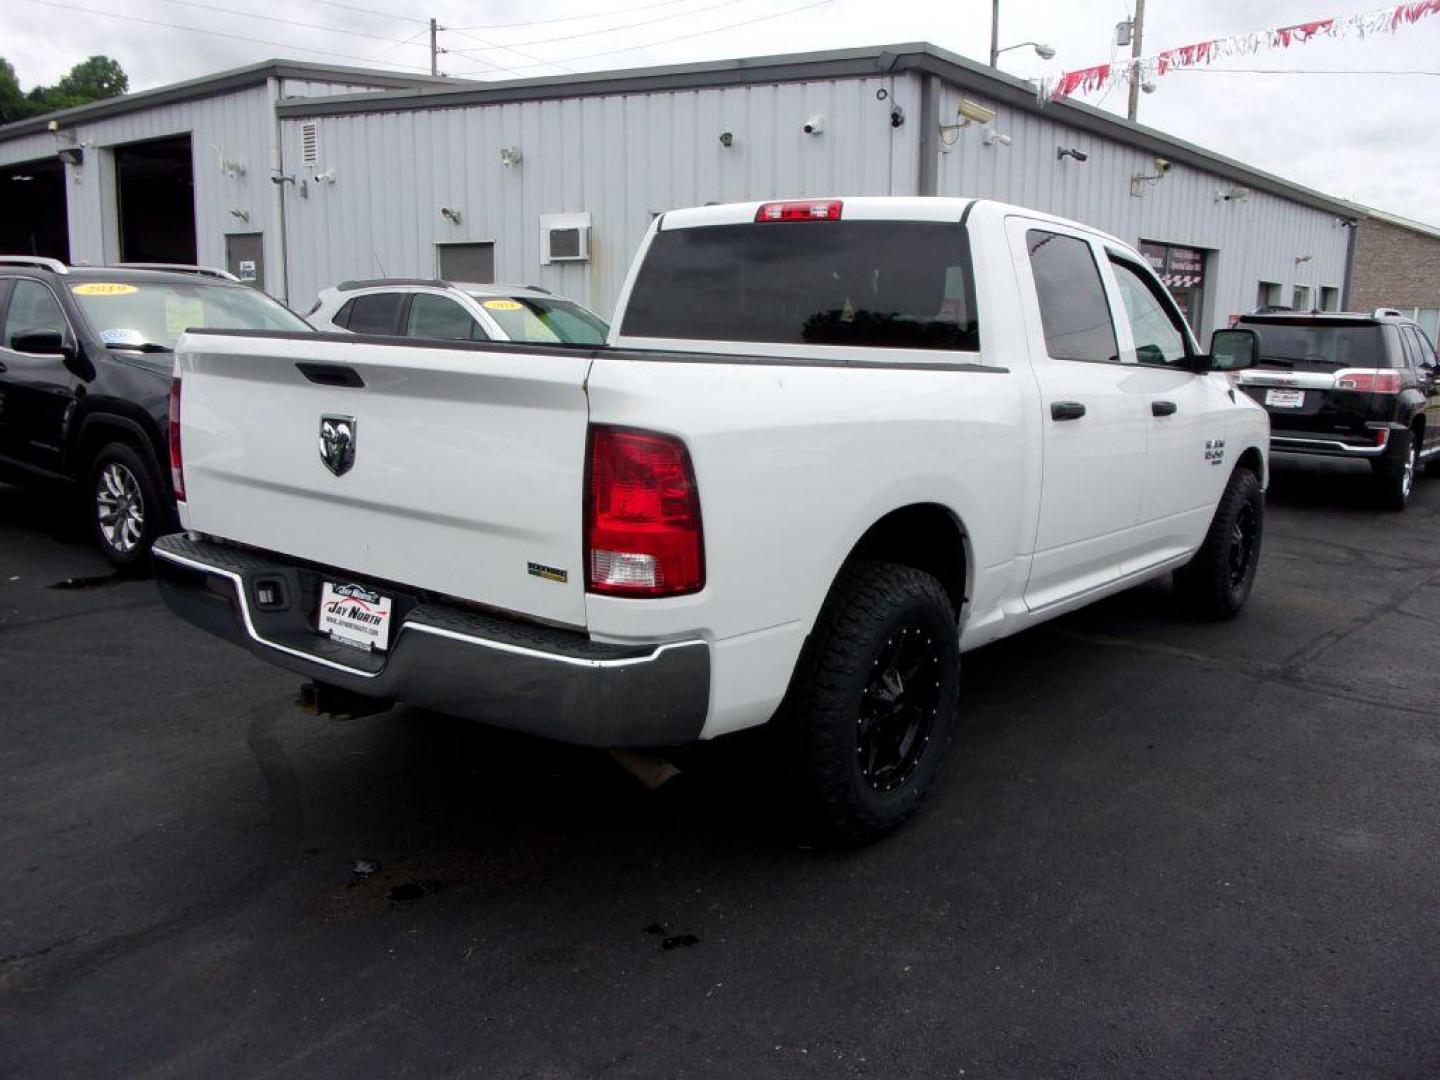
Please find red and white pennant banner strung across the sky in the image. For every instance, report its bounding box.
[1040,0,1440,101]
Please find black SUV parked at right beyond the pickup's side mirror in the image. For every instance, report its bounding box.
[1236,308,1440,510]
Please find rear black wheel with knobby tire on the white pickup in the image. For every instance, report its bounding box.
[782,560,960,847]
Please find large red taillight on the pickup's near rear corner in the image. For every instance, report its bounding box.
[585,425,706,596]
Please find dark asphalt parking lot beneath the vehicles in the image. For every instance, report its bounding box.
[0,467,1440,1080]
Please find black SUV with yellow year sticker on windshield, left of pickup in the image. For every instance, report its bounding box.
[0,256,310,569]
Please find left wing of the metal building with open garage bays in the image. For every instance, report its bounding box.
[0,60,446,297]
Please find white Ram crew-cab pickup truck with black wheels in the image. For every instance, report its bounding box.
[154,197,1269,842]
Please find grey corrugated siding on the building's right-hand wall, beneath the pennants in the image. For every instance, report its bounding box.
[937,86,1349,338]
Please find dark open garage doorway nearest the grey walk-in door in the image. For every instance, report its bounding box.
[115,135,196,262]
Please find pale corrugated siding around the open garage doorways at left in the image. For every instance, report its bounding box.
[0,86,279,283]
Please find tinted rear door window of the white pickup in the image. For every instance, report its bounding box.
[1025,229,1120,363]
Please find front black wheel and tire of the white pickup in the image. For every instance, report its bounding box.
[1175,468,1264,619]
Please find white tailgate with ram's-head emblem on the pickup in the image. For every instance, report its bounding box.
[176,333,590,626]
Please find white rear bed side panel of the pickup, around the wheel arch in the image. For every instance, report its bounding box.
[586,356,1031,734]
